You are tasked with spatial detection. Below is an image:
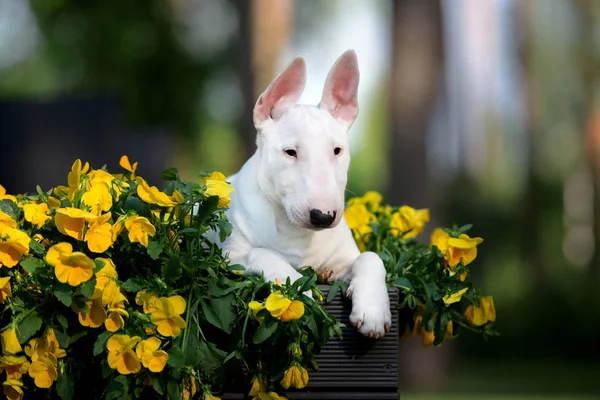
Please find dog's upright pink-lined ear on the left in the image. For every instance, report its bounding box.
[254,57,306,129]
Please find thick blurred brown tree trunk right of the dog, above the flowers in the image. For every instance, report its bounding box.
[387,0,442,207]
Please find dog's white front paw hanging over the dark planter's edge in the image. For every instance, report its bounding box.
[347,286,392,339]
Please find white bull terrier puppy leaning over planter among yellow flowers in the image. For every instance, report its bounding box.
[222,50,391,338]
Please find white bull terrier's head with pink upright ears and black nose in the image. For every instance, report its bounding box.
[254,50,359,229]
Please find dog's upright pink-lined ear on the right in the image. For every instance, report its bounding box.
[319,50,359,128]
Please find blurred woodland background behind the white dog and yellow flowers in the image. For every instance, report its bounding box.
[0,0,600,400]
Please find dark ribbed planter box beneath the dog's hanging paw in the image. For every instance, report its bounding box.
[223,285,400,400]
